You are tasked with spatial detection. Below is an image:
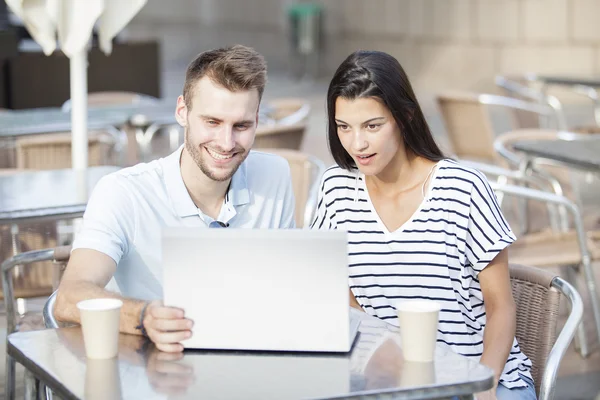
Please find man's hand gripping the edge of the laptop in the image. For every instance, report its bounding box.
[143,300,194,353]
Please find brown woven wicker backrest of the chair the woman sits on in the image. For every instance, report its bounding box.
[510,265,561,392]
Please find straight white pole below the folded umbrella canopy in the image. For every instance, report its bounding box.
[70,48,88,170]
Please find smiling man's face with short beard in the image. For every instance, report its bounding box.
[177,76,260,181]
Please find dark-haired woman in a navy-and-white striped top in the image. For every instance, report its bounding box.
[313,51,535,400]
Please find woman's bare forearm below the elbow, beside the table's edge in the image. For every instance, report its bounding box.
[480,313,516,383]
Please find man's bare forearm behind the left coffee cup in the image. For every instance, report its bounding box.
[54,281,144,334]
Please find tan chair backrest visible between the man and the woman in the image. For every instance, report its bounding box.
[258,149,325,228]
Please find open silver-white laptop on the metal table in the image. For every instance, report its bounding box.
[162,227,359,352]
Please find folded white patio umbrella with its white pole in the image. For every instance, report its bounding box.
[6,0,147,169]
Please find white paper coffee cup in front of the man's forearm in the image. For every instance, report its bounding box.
[77,299,123,359]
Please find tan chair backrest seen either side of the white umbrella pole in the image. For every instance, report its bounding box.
[16,129,124,170]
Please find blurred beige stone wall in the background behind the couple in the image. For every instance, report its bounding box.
[129,0,600,100]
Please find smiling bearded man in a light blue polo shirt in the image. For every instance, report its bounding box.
[54,45,294,352]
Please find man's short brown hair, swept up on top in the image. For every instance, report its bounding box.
[183,45,267,108]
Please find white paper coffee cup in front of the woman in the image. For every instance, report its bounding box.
[396,300,441,362]
